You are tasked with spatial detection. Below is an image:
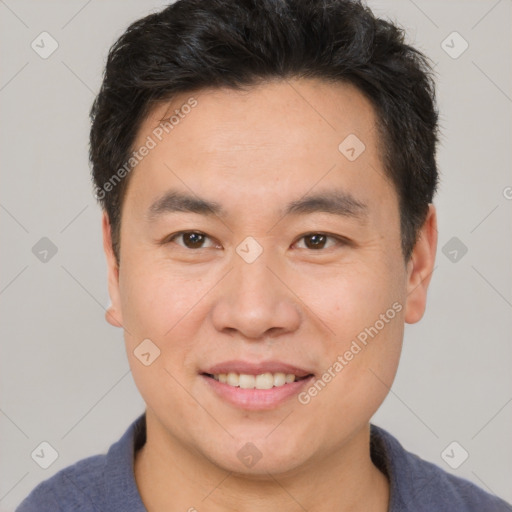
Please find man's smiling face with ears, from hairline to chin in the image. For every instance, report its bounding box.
[103,80,436,475]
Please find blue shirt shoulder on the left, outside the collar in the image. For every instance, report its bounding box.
[16,455,107,512]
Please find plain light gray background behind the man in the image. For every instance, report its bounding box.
[0,0,512,511]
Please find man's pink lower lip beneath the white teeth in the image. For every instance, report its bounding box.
[200,375,313,411]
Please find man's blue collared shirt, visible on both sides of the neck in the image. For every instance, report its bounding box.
[16,414,512,512]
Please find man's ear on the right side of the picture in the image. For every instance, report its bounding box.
[405,204,437,324]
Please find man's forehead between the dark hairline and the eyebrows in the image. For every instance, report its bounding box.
[125,79,396,222]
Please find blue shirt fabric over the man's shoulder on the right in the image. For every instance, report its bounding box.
[371,424,512,512]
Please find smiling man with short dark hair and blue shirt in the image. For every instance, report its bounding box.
[18,0,510,512]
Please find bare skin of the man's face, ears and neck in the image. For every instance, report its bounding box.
[103,79,437,512]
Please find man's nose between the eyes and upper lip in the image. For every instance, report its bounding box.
[212,251,301,341]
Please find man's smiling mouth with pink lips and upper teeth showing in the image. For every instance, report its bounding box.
[199,361,314,410]
